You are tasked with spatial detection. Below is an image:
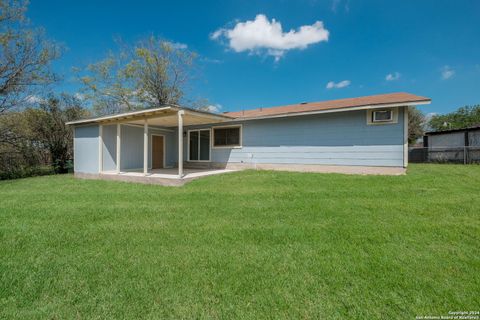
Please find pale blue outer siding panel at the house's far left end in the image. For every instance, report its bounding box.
[73,125,99,173]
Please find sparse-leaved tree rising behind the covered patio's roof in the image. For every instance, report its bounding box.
[76,37,196,115]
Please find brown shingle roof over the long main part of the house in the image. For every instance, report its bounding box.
[224,92,431,118]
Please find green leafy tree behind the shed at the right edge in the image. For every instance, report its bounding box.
[429,105,480,131]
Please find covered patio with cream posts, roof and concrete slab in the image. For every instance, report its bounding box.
[69,106,232,183]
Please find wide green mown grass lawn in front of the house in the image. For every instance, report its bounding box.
[0,165,480,319]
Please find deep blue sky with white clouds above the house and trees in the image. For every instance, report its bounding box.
[27,0,480,113]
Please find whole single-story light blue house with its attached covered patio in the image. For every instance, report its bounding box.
[68,93,430,181]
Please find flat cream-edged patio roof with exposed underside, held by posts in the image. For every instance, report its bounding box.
[67,105,233,127]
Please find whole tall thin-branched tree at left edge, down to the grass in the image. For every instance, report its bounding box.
[0,0,60,178]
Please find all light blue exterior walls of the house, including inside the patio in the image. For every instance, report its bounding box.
[74,107,405,173]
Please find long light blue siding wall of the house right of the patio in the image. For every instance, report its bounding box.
[184,108,404,167]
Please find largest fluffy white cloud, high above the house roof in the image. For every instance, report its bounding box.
[210,14,329,61]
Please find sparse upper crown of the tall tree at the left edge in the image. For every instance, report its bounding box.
[0,0,60,114]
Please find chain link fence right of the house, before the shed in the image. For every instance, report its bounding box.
[408,146,480,164]
